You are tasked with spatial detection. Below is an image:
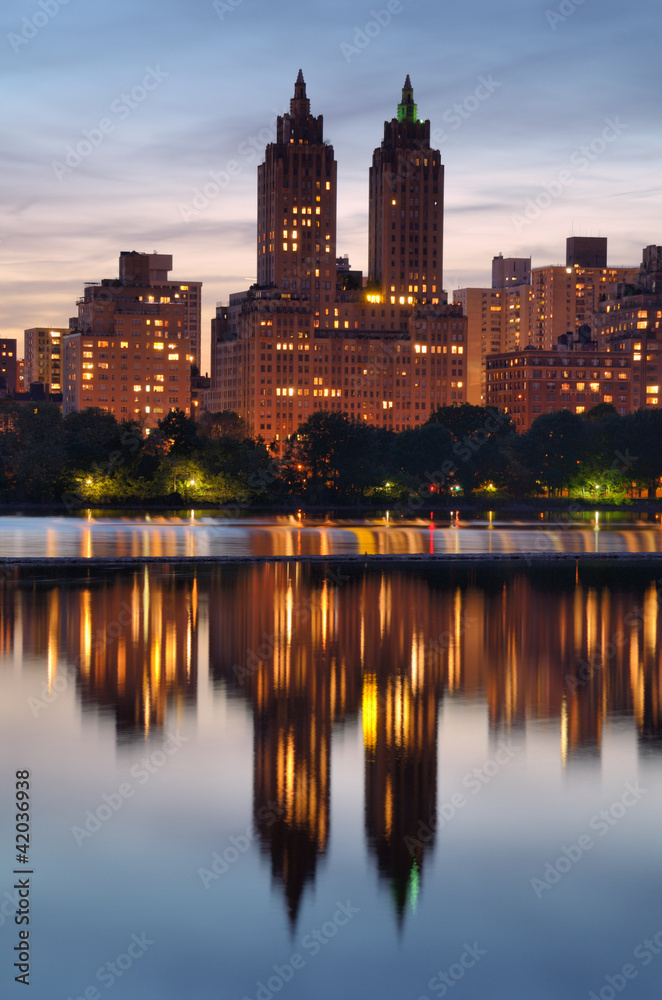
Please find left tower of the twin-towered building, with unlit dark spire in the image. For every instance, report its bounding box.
[257,70,336,318]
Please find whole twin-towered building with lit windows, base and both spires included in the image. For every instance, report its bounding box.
[213,72,467,441]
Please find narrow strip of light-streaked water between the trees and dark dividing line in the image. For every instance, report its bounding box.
[0,511,662,559]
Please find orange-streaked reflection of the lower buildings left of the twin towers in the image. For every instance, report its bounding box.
[0,567,198,739]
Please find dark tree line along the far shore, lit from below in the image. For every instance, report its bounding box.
[0,401,662,506]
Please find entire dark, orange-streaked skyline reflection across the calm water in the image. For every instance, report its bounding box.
[0,564,662,920]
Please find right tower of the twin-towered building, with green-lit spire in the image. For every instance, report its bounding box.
[369,76,444,305]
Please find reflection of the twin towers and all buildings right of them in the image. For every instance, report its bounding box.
[210,565,662,922]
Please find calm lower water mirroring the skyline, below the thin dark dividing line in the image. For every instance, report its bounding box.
[0,560,662,1000]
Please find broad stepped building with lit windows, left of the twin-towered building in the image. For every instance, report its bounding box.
[63,253,201,429]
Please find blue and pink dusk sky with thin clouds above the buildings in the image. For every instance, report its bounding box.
[0,0,662,370]
